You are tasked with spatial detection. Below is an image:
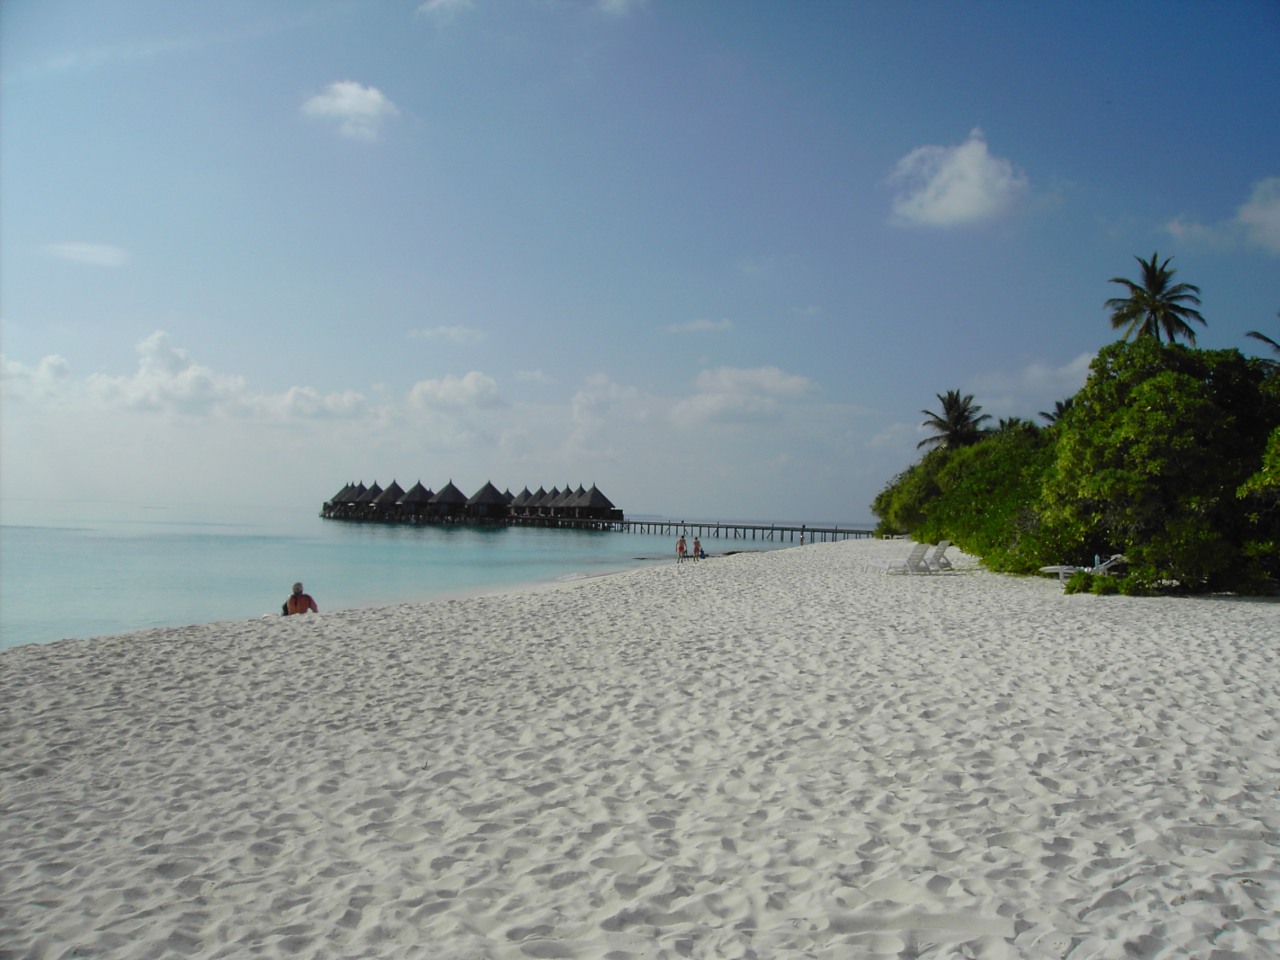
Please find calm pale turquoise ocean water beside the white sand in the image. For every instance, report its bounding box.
[0,500,791,648]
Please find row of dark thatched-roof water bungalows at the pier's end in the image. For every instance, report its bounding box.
[320,480,623,526]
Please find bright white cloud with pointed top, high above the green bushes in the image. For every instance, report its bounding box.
[890,129,1029,227]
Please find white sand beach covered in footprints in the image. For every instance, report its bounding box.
[0,541,1280,960]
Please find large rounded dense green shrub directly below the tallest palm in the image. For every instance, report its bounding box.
[1041,338,1280,590]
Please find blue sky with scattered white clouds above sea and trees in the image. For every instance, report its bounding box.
[0,0,1280,524]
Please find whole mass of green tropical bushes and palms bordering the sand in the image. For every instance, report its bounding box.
[872,256,1280,593]
